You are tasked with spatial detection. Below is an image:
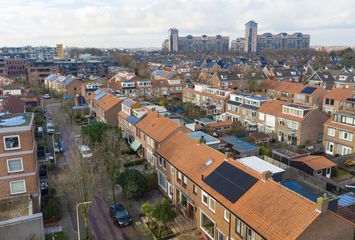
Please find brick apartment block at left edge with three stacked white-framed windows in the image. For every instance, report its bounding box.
[0,113,40,204]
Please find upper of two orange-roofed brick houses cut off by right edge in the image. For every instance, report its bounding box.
[323,88,355,115]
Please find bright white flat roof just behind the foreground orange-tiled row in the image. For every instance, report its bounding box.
[236,156,285,174]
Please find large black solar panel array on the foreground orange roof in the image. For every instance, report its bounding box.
[203,162,257,203]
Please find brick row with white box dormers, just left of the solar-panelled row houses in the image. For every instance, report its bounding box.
[182,84,231,115]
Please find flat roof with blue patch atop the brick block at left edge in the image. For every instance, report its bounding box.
[0,113,33,128]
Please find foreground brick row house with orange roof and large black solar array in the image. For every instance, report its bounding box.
[156,132,354,240]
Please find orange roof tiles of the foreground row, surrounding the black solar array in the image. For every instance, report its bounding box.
[157,132,320,240]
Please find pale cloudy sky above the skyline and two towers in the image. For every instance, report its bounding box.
[0,0,355,47]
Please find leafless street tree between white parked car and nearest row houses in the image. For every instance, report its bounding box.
[95,128,126,203]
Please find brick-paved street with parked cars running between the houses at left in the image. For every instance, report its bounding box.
[45,101,142,240]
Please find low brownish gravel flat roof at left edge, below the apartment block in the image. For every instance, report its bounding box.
[0,195,31,222]
